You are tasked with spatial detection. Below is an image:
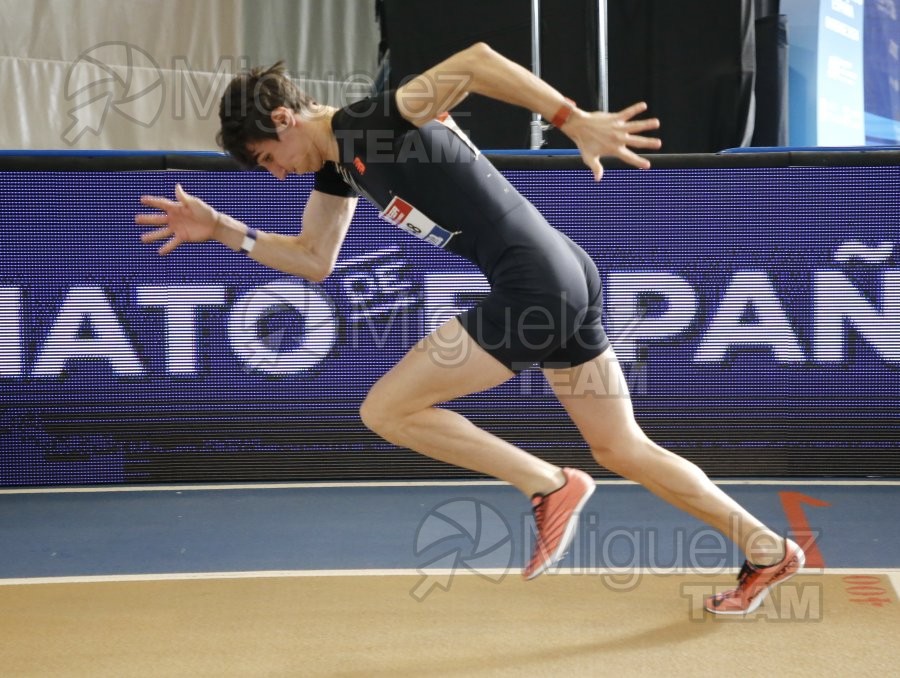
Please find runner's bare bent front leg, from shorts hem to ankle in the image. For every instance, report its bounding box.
[360,318,564,497]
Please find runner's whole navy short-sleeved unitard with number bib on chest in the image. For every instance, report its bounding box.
[315,90,609,371]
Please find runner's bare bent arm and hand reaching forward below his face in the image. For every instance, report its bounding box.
[135,185,357,282]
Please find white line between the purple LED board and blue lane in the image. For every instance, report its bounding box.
[0,479,900,495]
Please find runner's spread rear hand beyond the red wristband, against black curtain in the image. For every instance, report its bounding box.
[562,101,662,181]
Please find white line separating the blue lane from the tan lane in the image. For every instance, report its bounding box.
[0,567,900,596]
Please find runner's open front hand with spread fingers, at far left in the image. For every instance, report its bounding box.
[134,184,219,254]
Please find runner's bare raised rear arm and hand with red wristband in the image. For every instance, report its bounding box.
[397,42,661,180]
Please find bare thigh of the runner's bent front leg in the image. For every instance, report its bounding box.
[369,318,515,411]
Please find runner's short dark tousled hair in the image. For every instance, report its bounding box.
[216,61,315,167]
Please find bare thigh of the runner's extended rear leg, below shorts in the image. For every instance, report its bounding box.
[544,347,640,447]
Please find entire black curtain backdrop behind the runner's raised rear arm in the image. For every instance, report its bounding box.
[381,0,787,153]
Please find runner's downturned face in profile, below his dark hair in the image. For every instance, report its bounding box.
[247,108,325,179]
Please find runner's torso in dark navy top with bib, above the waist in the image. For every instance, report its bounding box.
[317,91,561,279]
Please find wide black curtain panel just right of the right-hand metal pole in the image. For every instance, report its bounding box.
[608,0,756,153]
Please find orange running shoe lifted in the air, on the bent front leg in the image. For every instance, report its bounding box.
[522,468,597,579]
